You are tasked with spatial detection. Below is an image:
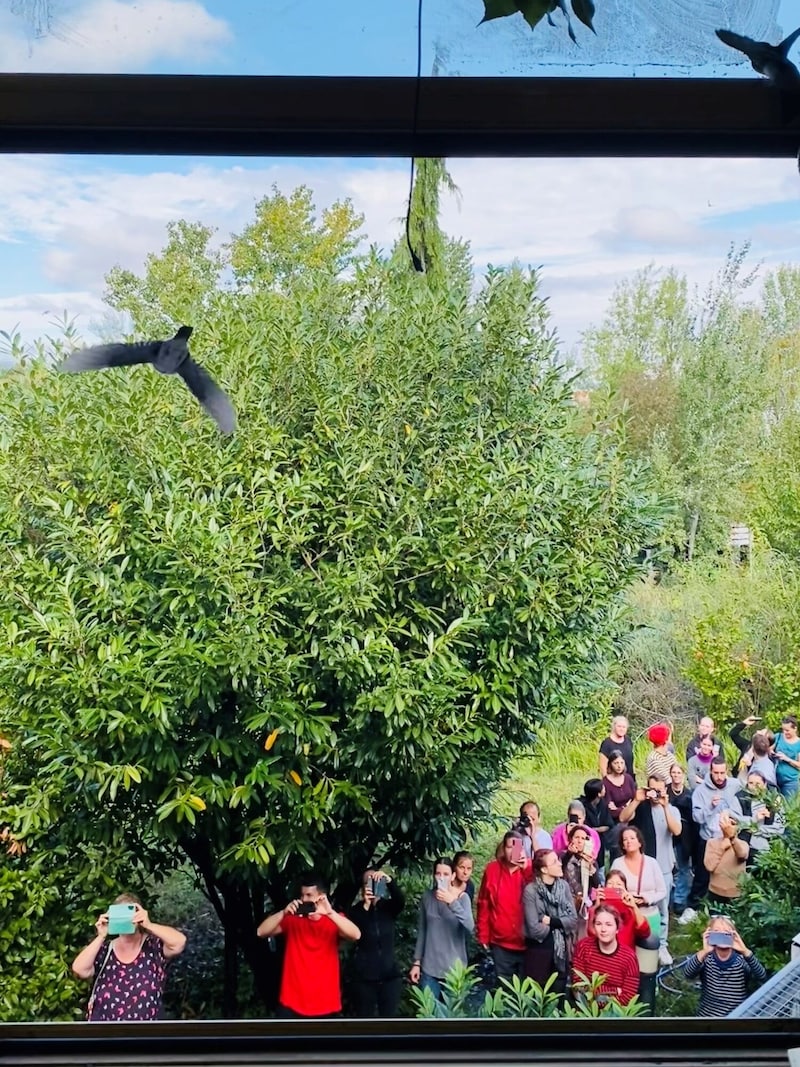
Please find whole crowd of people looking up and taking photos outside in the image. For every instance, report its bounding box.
[73,716,800,1020]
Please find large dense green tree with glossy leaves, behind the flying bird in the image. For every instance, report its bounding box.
[0,191,658,1012]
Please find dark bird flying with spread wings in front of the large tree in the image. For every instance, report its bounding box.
[59,327,236,433]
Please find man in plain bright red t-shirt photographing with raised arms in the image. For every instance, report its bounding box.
[258,874,362,1019]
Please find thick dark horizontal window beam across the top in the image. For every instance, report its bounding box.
[0,74,800,157]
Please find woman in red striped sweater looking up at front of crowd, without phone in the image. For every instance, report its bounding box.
[572,904,639,1004]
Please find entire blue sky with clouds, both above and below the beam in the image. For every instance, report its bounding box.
[0,0,800,346]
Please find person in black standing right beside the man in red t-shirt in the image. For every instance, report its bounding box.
[348,870,405,1019]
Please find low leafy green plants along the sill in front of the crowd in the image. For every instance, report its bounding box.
[412,961,647,1019]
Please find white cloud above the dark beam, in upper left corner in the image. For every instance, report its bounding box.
[0,0,233,74]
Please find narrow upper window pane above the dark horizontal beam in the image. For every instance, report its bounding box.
[0,0,800,77]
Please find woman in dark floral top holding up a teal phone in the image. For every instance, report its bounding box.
[73,893,186,1022]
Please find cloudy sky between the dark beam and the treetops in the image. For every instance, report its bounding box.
[0,156,800,344]
